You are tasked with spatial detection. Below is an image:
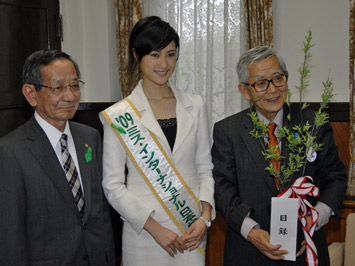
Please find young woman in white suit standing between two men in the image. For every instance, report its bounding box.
[100,17,215,266]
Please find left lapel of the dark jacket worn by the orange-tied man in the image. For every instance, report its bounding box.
[241,108,278,194]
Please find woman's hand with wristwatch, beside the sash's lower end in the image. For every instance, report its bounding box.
[181,219,207,251]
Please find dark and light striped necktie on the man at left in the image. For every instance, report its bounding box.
[60,134,85,217]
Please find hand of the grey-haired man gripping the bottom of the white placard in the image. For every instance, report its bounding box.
[248,228,288,260]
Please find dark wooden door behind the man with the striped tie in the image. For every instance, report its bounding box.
[0,0,61,137]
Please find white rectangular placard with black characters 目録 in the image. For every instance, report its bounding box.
[270,198,298,261]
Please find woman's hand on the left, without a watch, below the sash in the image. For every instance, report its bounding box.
[144,217,187,257]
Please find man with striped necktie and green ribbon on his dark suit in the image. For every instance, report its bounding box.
[0,50,115,266]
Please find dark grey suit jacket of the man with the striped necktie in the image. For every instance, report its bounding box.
[0,117,115,266]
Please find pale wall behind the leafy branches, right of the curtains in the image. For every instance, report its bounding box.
[272,0,350,102]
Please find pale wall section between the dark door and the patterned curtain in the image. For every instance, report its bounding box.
[60,0,121,102]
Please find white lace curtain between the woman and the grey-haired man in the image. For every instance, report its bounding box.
[142,0,248,132]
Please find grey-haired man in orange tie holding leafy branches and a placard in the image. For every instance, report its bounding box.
[212,47,346,266]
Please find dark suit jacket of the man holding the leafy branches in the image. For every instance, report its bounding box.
[212,106,346,266]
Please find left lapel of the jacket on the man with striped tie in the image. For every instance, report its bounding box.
[26,116,80,216]
